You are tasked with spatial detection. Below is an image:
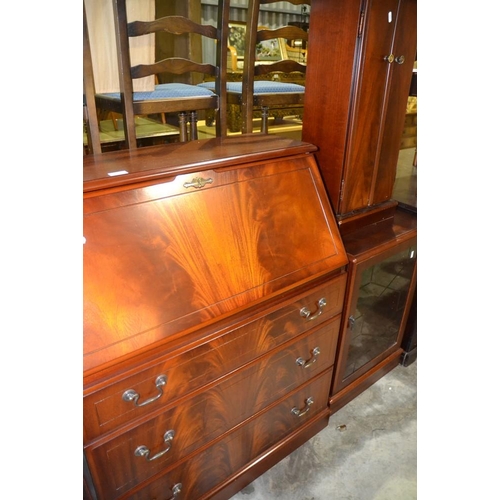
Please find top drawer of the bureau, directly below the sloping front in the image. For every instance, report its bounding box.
[83,273,346,443]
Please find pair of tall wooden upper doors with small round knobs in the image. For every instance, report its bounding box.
[340,0,417,214]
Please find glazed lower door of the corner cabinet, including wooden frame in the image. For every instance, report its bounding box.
[334,239,417,392]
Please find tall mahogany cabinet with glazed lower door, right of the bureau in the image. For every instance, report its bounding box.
[302,0,417,412]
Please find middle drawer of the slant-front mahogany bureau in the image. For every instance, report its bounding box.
[87,318,340,498]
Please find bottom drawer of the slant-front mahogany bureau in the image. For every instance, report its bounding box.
[123,369,332,500]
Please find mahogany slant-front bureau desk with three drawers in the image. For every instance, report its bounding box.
[84,135,348,500]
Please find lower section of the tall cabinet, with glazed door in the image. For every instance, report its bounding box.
[330,209,417,412]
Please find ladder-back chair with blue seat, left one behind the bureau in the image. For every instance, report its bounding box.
[96,0,230,148]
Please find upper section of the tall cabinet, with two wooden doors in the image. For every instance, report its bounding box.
[302,0,417,220]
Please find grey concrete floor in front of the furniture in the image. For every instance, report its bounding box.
[231,361,417,500]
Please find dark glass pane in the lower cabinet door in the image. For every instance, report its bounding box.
[344,247,416,378]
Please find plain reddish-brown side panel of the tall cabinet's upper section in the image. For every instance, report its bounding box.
[302,0,363,215]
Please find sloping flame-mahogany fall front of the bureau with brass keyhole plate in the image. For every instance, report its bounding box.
[84,146,346,369]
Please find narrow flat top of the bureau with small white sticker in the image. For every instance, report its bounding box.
[83,134,317,193]
